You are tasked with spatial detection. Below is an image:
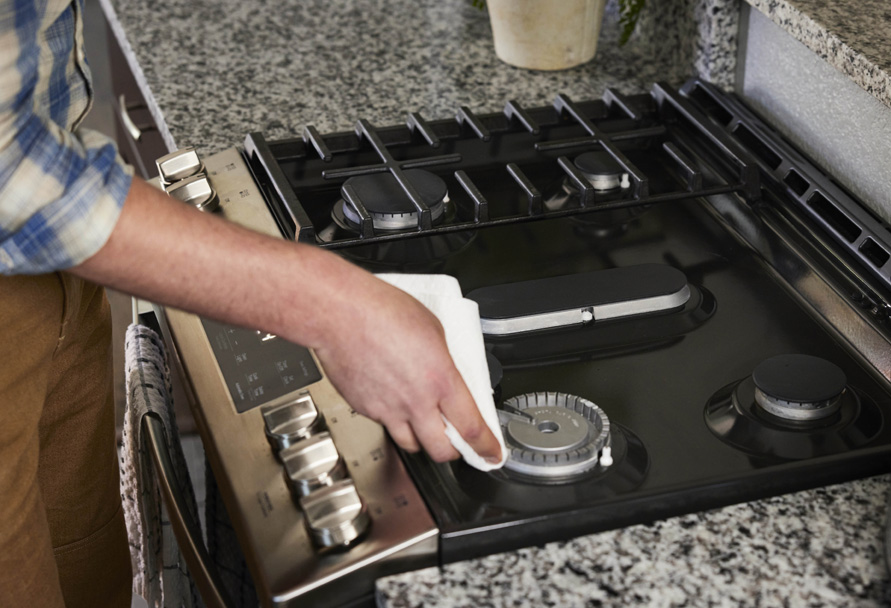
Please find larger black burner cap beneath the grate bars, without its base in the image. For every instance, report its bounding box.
[344,169,447,214]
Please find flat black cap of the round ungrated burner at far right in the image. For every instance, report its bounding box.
[752,354,847,403]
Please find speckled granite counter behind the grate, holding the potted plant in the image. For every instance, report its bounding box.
[102,0,737,159]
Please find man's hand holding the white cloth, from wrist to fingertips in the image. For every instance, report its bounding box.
[315,275,501,462]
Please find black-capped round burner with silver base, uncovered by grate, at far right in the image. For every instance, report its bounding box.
[752,354,847,420]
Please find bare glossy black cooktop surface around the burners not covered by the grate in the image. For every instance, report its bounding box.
[396,200,891,561]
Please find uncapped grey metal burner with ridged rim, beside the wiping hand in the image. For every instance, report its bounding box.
[499,392,612,480]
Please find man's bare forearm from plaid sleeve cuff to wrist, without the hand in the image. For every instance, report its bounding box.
[71,173,348,347]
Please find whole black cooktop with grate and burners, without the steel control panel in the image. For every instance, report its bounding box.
[246,82,891,561]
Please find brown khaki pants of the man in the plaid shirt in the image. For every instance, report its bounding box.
[0,273,132,608]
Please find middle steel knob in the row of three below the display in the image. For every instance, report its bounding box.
[279,433,347,498]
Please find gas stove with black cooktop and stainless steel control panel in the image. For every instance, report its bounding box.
[158,80,891,606]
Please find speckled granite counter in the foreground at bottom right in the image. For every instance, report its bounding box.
[378,476,891,608]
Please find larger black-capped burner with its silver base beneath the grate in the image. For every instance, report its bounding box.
[335,169,448,230]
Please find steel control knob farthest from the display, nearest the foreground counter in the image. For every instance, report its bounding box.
[300,479,371,548]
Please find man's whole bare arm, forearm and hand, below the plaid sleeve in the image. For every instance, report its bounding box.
[71,178,501,461]
